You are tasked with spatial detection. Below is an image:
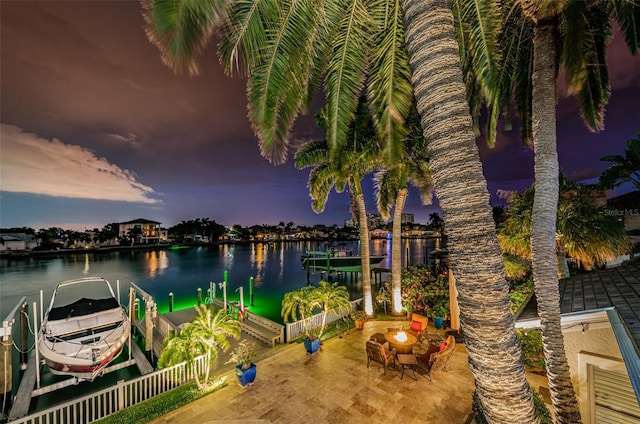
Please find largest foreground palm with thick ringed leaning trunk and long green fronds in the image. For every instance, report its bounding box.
[145,0,536,423]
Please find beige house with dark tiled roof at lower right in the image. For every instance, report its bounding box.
[516,262,640,423]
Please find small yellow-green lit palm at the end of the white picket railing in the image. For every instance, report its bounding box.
[158,305,242,389]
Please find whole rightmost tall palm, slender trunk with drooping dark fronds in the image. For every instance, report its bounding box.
[458,0,640,423]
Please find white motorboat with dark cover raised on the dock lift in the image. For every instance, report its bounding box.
[38,277,131,381]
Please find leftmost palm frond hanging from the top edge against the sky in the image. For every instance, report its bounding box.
[142,0,226,76]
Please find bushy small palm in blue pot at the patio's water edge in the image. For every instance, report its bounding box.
[281,281,351,354]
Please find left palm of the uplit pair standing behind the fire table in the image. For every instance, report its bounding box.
[294,107,377,315]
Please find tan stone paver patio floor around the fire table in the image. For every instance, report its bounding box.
[151,321,474,424]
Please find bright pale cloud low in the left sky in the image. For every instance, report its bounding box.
[0,124,159,204]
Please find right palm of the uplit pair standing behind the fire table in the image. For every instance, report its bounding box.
[374,109,433,314]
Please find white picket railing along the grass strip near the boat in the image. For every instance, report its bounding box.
[11,356,205,424]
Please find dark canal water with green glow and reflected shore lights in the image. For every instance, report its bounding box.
[0,239,436,418]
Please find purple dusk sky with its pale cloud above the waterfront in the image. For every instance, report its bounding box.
[0,0,640,230]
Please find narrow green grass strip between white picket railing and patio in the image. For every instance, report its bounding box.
[97,380,227,424]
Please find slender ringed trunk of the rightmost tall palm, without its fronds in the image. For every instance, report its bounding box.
[531,21,581,423]
